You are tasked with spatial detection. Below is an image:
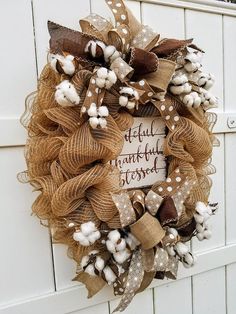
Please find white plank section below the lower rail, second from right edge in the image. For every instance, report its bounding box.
[193,267,226,314]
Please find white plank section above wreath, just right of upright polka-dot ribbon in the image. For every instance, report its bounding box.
[141,3,184,39]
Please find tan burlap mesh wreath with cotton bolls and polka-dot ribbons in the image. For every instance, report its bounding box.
[23,0,217,311]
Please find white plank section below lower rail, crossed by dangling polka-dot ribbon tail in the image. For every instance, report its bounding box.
[110,289,153,314]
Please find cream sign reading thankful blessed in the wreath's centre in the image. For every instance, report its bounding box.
[112,117,166,188]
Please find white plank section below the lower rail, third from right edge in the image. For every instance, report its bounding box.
[154,278,193,314]
